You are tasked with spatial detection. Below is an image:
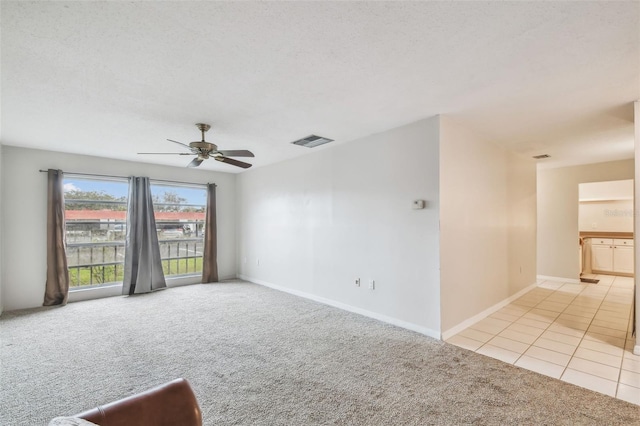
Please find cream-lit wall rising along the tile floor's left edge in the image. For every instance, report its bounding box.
[440,117,536,335]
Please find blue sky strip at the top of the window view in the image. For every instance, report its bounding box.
[64,177,207,205]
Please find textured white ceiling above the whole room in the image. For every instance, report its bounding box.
[0,1,640,172]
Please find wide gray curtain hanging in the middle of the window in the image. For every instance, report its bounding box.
[122,177,167,295]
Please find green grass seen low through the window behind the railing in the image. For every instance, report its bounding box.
[69,257,202,287]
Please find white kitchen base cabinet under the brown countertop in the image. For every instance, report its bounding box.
[591,238,634,274]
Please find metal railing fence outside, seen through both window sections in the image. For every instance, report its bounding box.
[67,238,204,287]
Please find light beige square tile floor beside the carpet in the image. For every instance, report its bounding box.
[447,275,640,405]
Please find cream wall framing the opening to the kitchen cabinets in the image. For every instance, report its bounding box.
[538,160,634,280]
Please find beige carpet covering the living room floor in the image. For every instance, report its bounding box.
[0,282,640,426]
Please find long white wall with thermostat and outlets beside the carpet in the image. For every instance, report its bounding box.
[237,117,440,336]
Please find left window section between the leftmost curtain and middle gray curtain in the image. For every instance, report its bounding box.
[64,175,129,289]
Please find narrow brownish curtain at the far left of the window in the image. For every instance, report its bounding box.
[43,169,69,306]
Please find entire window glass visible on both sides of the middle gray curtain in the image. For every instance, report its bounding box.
[64,175,207,290]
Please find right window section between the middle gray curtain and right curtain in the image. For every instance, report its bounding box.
[151,181,207,277]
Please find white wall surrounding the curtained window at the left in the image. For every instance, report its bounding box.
[1,145,236,311]
